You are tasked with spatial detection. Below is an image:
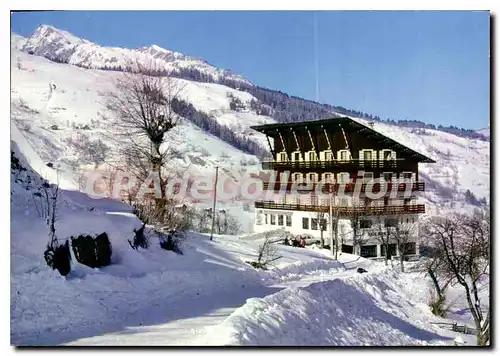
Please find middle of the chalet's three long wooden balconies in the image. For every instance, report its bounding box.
[263,181,425,194]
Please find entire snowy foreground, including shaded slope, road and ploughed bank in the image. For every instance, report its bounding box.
[10,141,484,346]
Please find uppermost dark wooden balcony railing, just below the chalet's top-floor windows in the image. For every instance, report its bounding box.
[262,159,406,171]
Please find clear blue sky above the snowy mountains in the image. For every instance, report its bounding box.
[11,11,490,128]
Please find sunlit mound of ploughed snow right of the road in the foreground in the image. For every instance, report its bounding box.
[211,271,453,346]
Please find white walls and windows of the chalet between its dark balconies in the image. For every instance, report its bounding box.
[254,148,424,257]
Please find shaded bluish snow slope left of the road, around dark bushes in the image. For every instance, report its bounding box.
[10,141,344,346]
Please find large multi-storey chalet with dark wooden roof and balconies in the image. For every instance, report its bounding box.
[252,117,434,258]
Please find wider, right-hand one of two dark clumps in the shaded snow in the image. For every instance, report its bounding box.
[71,232,112,268]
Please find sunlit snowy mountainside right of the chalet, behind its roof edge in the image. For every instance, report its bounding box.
[355,118,490,211]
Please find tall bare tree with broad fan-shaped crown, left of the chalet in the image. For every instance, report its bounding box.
[107,62,182,198]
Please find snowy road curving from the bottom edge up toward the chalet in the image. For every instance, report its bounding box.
[66,260,369,346]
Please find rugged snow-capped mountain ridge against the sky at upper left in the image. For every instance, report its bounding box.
[22,25,249,83]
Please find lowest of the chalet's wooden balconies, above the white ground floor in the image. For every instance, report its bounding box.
[255,201,425,217]
